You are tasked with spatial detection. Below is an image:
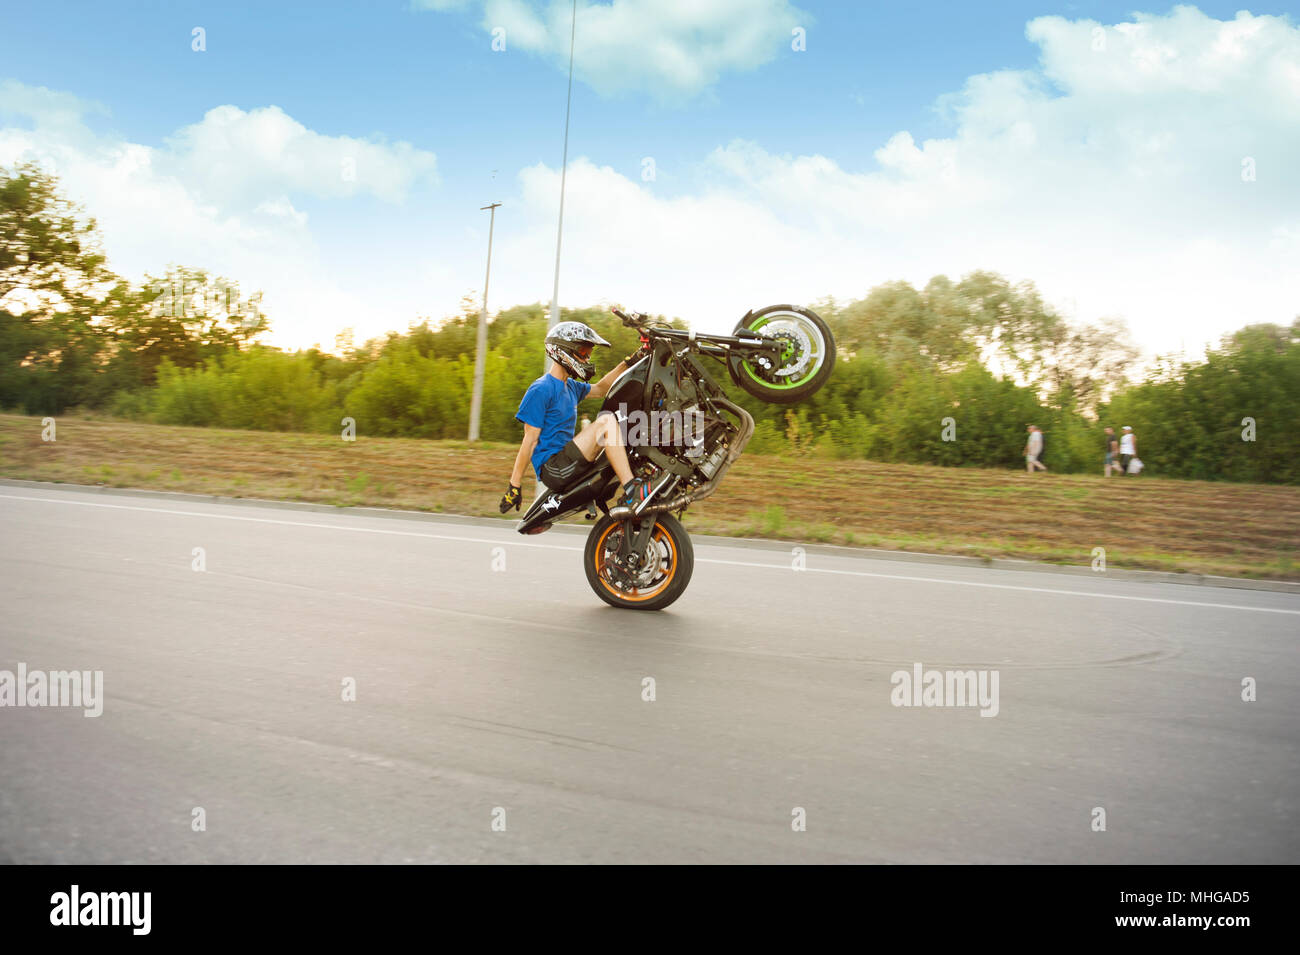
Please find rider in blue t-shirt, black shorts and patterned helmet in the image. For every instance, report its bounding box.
[499,322,649,520]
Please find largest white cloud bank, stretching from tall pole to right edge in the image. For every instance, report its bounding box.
[488,8,1300,351]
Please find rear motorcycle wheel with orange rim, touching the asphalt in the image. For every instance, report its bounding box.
[582,513,696,611]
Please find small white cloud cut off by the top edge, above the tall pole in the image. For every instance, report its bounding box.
[417,0,813,100]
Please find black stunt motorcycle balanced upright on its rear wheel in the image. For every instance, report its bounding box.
[516,305,835,611]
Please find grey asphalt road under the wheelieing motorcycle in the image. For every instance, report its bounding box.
[0,486,1300,863]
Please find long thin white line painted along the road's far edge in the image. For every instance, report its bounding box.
[0,494,1300,616]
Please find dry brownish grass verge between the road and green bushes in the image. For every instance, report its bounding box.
[0,414,1300,579]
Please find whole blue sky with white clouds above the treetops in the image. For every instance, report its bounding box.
[0,0,1300,351]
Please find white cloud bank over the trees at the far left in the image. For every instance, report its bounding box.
[0,81,437,347]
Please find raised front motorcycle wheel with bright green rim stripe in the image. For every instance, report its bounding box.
[728,305,835,404]
